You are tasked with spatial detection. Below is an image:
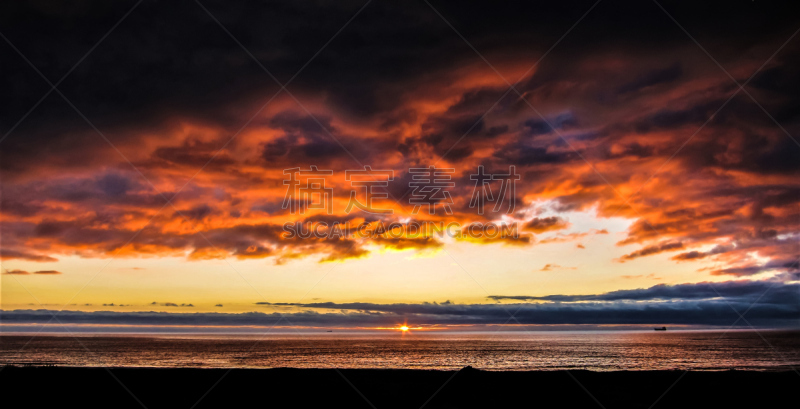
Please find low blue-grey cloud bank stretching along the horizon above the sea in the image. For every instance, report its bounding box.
[0,281,800,327]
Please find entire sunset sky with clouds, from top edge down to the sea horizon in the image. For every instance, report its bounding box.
[0,0,800,329]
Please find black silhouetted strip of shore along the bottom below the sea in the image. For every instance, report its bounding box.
[0,366,800,408]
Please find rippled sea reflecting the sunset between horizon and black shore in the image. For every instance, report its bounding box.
[0,331,800,371]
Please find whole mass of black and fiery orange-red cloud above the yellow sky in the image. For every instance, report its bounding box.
[0,3,800,276]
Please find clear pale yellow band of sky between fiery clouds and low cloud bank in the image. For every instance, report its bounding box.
[0,202,727,312]
